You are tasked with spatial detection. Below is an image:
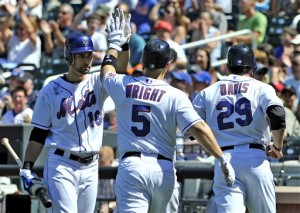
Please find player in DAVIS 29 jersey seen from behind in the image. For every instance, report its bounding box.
[193,44,285,213]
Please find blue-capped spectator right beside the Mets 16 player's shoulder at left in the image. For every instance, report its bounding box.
[17,72,39,110]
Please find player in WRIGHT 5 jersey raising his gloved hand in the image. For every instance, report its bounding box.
[101,9,235,213]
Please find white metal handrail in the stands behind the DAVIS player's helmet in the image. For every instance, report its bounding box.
[181,29,257,67]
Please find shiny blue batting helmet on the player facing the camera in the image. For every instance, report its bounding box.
[65,32,95,65]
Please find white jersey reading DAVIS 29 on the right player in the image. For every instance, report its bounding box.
[193,75,282,147]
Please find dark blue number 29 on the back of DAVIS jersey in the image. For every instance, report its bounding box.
[216,97,253,130]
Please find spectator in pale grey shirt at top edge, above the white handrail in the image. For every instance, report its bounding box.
[201,0,228,34]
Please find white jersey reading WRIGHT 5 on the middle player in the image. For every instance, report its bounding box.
[103,73,201,159]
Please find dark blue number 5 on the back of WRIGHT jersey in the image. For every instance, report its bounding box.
[131,105,151,137]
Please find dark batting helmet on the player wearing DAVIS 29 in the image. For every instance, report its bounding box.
[227,44,257,73]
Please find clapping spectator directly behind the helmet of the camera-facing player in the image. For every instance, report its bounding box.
[41,3,74,60]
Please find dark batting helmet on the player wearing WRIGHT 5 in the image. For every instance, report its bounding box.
[142,39,172,69]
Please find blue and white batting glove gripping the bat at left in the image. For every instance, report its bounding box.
[20,169,46,196]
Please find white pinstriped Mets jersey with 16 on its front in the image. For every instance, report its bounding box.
[32,73,107,152]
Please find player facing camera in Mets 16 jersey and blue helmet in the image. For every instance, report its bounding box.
[20,32,107,213]
